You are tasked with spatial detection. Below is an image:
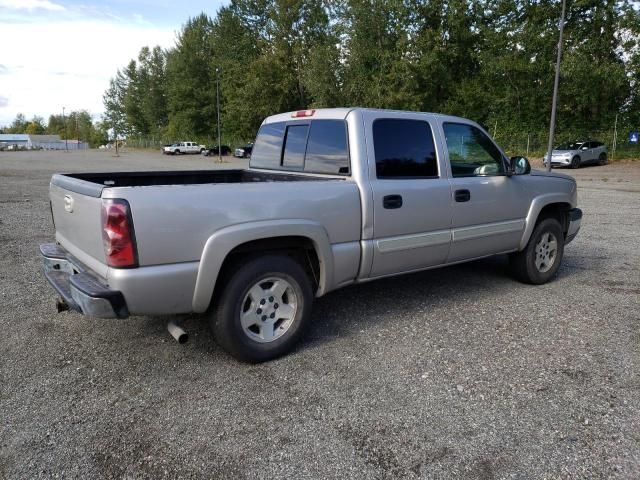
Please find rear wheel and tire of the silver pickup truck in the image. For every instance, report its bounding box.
[209,255,313,363]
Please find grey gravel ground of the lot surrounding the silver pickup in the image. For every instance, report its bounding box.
[0,152,640,479]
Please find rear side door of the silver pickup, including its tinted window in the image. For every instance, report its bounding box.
[363,111,451,277]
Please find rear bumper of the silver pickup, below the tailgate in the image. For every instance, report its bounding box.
[40,243,129,318]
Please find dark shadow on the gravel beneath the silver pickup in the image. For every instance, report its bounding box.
[155,255,604,357]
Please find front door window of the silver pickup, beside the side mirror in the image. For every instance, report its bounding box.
[443,123,505,177]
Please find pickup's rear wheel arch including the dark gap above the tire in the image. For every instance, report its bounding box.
[193,220,333,313]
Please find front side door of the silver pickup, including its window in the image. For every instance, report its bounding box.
[442,122,531,262]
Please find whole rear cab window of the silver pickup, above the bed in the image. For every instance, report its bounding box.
[250,119,350,175]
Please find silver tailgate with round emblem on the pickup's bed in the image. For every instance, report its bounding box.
[49,175,107,277]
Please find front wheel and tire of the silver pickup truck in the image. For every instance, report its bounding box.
[509,218,564,285]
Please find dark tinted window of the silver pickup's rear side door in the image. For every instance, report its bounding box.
[373,118,438,179]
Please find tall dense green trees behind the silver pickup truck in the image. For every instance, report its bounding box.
[104,0,640,146]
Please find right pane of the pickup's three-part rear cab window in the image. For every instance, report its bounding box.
[304,120,349,175]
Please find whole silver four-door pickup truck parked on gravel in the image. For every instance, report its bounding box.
[41,109,582,362]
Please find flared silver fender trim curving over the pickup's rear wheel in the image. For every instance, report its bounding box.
[193,219,333,313]
